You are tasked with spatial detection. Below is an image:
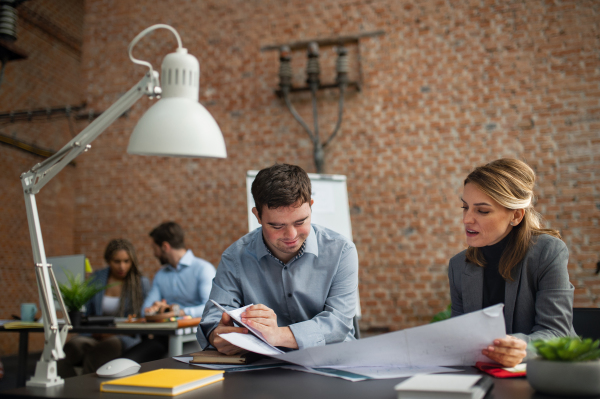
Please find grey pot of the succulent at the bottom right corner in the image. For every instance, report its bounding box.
[527,359,600,396]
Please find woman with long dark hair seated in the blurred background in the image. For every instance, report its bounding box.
[58,239,150,378]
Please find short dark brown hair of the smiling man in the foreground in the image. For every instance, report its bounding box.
[252,163,311,217]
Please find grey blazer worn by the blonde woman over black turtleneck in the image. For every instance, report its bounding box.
[448,234,576,342]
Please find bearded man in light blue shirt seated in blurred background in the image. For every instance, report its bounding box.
[144,222,216,317]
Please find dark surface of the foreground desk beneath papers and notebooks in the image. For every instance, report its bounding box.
[0,359,592,399]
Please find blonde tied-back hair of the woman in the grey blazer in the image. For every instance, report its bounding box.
[464,158,561,281]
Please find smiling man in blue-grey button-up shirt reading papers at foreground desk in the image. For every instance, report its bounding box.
[197,164,358,354]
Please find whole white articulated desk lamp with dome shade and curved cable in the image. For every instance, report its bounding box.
[21,24,227,387]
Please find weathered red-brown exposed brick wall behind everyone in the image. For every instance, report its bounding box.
[0,0,600,353]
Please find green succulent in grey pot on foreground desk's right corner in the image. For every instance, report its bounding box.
[527,337,600,396]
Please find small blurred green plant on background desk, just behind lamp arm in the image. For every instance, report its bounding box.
[55,269,107,326]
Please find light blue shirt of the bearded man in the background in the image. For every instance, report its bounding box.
[144,249,215,317]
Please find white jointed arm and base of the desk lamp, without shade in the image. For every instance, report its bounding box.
[21,71,160,387]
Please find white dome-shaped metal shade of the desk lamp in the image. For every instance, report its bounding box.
[127,48,227,158]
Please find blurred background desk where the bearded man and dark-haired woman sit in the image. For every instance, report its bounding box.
[0,326,198,387]
